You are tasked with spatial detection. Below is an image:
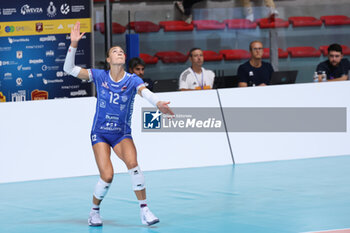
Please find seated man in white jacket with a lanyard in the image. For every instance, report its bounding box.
[179,48,215,91]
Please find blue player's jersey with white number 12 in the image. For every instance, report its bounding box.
[88,69,144,133]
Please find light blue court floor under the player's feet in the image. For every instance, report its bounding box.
[0,156,350,233]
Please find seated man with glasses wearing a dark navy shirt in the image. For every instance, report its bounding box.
[237,40,273,87]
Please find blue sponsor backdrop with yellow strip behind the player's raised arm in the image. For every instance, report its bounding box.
[0,0,92,102]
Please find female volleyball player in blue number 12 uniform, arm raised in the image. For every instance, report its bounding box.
[63,22,173,226]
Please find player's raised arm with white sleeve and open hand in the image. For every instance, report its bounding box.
[63,22,90,80]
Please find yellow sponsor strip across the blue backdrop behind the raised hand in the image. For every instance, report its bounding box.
[0,18,91,37]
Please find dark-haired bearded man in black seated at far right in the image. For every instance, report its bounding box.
[316,44,350,82]
